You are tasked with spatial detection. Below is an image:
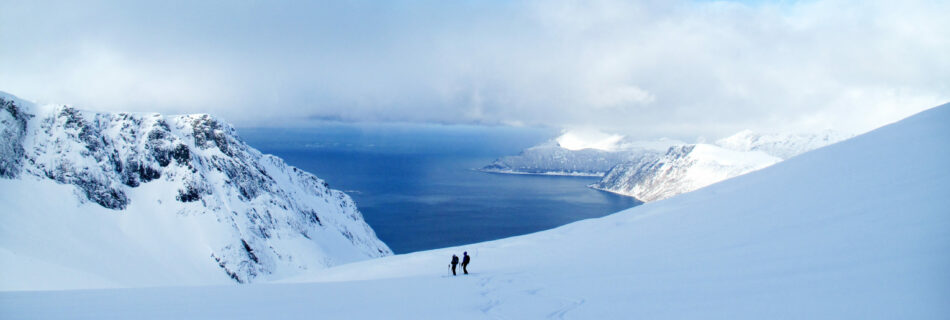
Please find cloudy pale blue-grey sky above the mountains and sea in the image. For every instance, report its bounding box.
[0,0,950,139]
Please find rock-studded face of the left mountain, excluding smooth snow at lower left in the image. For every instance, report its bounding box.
[0,95,391,283]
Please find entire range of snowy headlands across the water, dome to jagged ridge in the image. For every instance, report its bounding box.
[481,130,850,202]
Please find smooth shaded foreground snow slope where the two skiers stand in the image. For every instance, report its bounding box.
[0,105,950,319]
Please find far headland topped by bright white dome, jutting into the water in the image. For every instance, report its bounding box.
[481,131,682,177]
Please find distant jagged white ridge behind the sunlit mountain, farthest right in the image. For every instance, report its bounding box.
[716,130,851,159]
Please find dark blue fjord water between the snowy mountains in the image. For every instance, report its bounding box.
[238,123,640,253]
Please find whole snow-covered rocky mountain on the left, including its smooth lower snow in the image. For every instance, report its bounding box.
[0,94,391,289]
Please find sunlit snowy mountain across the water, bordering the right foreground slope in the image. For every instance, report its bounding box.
[591,144,781,202]
